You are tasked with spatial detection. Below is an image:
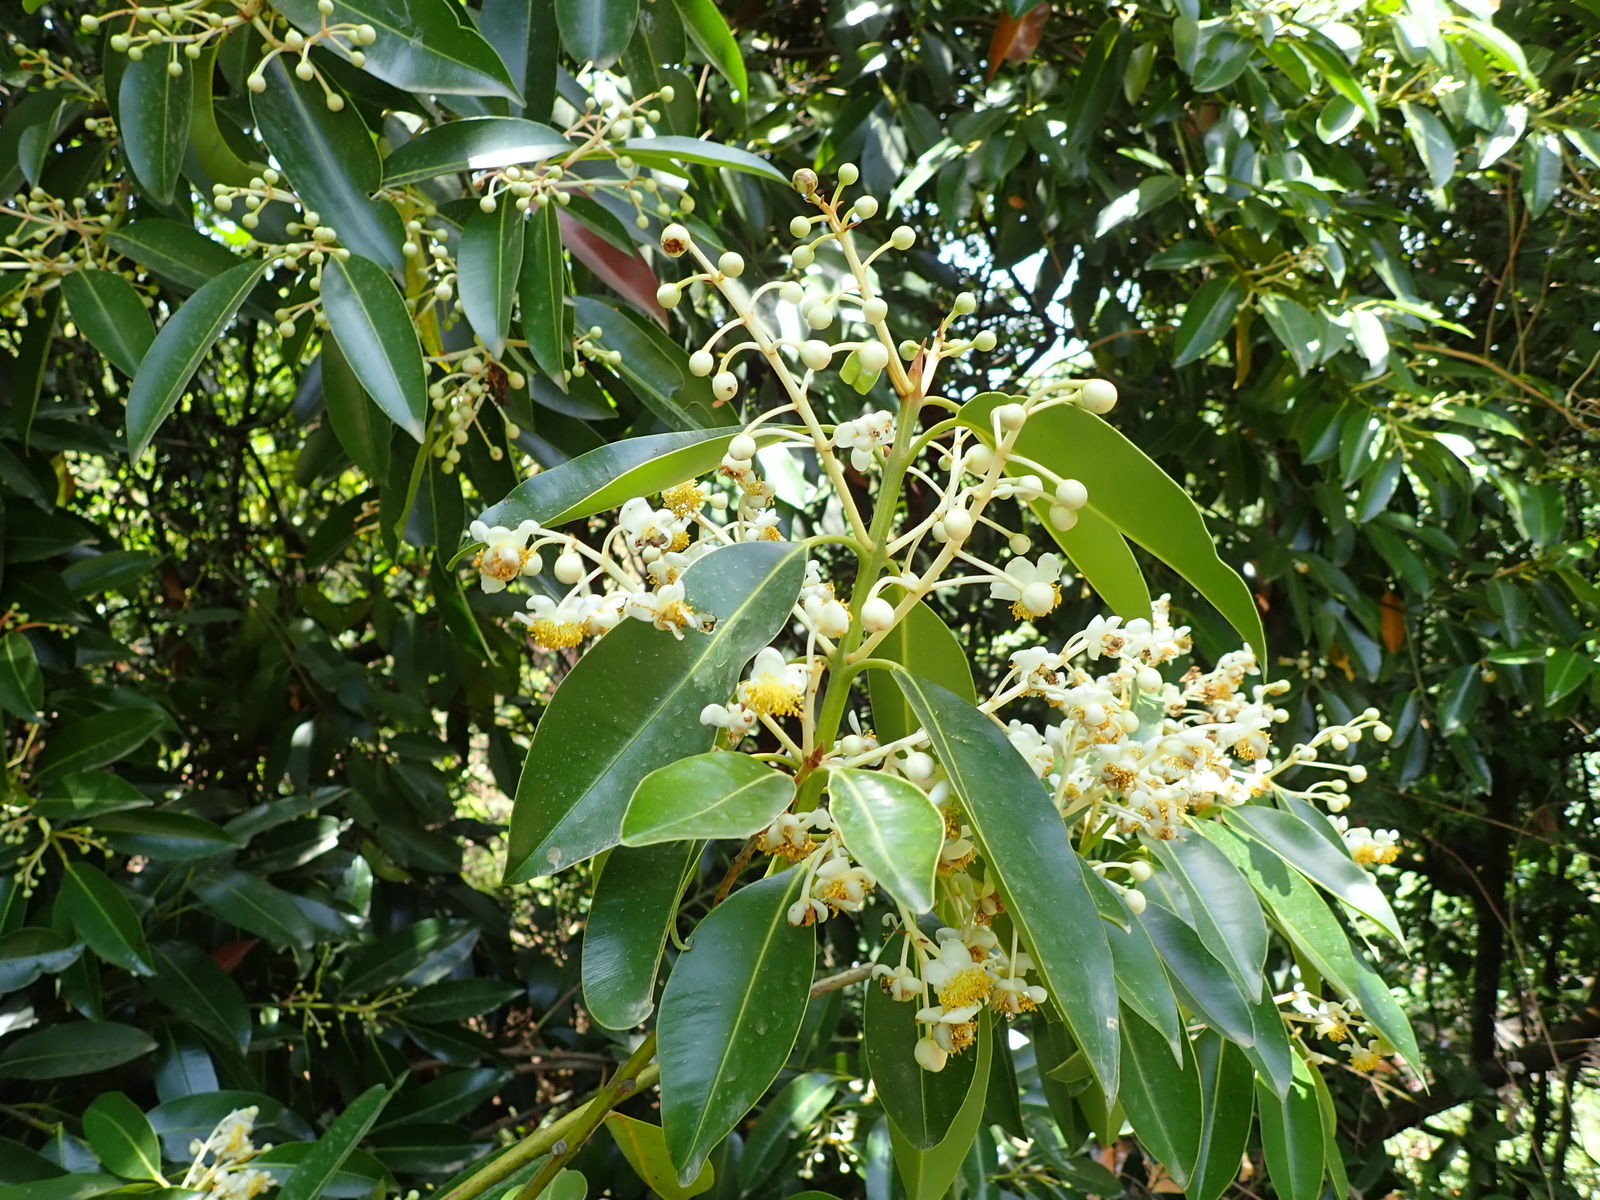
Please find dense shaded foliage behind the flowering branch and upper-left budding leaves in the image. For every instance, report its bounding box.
[0,0,1600,1197]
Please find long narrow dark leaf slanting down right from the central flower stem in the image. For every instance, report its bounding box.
[894,669,1118,1094]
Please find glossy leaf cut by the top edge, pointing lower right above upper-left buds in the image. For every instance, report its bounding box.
[274,0,522,101]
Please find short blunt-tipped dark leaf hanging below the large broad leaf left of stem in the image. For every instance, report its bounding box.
[582,842,701,1029]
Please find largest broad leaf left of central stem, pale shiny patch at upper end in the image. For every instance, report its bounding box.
[506,542,805,883]
